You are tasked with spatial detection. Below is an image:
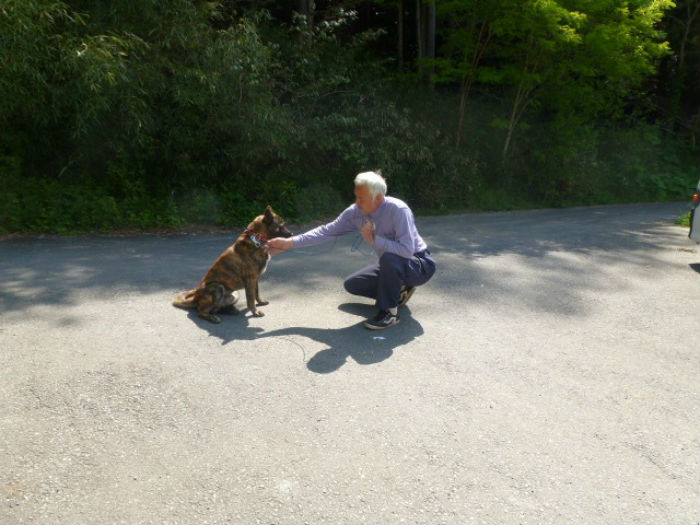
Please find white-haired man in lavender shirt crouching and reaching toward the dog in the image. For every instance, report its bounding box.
[268,171,435,330]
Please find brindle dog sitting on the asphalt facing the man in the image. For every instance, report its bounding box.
[173,206,292,323]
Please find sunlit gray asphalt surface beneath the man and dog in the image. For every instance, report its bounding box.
[0,203,700,525]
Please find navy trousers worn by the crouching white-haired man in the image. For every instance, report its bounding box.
[343,250,435,310]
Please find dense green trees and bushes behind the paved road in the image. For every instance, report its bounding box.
[0,0,700,233]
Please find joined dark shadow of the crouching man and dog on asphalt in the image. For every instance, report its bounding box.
[190,303,423,374]
